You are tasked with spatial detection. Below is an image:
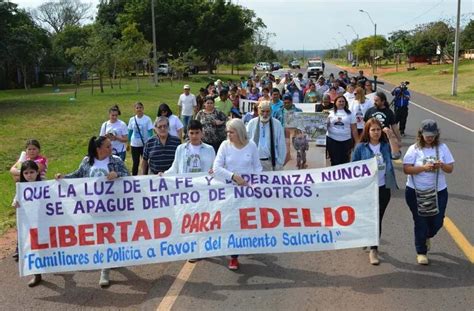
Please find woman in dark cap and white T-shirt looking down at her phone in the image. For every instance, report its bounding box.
[403,120,454,265]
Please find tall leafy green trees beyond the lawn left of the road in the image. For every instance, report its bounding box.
[0,0,276,92]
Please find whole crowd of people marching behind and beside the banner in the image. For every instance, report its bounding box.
[10,71,454,287]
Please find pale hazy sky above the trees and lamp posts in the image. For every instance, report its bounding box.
[11,0,474,50]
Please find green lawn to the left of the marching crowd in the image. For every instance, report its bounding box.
[0,74,244,234]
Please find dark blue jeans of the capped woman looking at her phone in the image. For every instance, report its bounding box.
[405,187,448,255]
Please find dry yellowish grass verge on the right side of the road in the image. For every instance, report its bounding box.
[382,60,474,110]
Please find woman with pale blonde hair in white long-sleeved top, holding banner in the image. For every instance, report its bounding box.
[213,119,262,270]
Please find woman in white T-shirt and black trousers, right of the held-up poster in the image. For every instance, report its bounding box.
[326,95,359,166]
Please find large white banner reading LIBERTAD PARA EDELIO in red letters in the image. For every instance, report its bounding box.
[17,159,378,276]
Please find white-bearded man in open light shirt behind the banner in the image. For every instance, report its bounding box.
[247,101,286,171]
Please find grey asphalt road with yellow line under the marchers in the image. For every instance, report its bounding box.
[0,64,474,310]
